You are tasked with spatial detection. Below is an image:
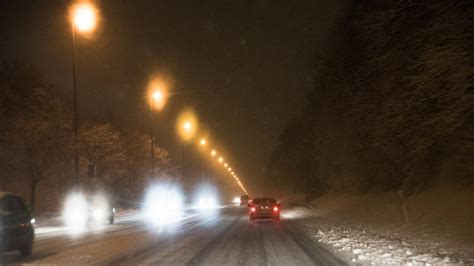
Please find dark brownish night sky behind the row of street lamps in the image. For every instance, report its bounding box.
[0,0,343,189]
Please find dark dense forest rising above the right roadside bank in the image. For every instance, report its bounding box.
[267,0,474,195]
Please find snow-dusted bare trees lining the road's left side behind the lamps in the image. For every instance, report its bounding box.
[0,64,170,210]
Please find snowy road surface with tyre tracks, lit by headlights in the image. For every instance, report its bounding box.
[0,207,344,265]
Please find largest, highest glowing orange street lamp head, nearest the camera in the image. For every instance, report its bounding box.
[71,2,98,33]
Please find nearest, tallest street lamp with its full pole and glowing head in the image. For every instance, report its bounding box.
[69,2,98,181]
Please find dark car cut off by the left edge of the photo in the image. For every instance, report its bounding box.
[0,192,35,256]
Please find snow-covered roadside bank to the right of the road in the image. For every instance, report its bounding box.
[282,187,474,265]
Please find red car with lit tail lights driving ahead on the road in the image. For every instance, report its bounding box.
[248,197,281,221]
